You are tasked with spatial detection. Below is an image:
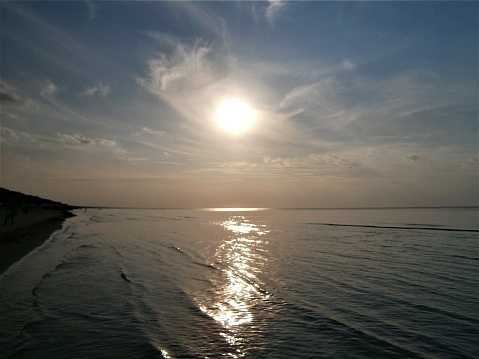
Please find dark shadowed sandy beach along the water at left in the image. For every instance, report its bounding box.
[0,208,73,274]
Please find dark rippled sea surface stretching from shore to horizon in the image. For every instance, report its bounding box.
[0,208,479,359]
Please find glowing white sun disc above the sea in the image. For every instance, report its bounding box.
[215,98,256,134]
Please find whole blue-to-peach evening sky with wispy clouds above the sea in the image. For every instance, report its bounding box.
[0,1,479,208]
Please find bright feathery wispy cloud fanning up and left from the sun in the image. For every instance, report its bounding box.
[137,38,231,137]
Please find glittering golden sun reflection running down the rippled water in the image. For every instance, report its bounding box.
[197,215,269,358]
